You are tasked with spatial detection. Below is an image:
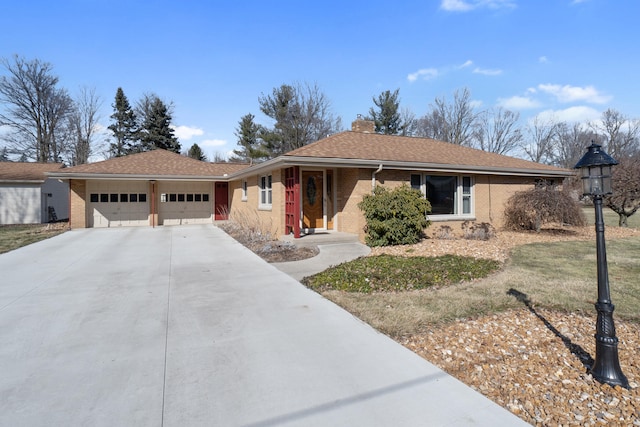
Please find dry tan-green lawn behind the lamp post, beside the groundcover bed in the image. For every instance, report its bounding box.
[323,222,640,338]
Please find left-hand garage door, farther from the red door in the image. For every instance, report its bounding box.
[87,181,151,227]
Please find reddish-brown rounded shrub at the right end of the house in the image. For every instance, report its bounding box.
[504,185,586,232]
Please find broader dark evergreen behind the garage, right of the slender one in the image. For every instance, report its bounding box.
[140,96,180,153]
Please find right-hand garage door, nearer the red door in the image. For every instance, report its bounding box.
[158,182,213,225]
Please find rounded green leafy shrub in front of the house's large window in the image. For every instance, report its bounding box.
[358,185,431,246]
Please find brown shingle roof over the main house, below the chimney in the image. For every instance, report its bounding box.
[285,131,568,172]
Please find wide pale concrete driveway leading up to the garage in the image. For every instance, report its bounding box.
[0,225,525,426]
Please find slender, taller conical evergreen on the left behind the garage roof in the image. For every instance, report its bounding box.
[108,87,138,157]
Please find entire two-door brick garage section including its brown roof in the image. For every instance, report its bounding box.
[49,149,248,228]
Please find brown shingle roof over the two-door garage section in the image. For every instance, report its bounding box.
[49,149,248,178]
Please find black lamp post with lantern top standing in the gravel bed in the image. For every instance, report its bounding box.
[574,142,629,388]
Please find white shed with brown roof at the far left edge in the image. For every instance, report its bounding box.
[0,162,69,225]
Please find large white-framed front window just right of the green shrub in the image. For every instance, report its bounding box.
[411,174,473,219]
